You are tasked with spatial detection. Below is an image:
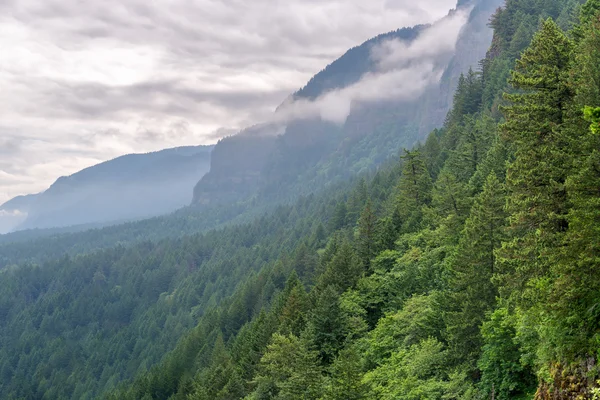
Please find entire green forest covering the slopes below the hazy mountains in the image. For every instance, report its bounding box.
[0,0,600,400]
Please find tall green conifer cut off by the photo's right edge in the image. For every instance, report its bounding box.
[544,15,600,359]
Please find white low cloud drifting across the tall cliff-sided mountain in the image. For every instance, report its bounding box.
[275,10,470,124]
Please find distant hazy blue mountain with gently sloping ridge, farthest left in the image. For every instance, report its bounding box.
[13,146,213,230]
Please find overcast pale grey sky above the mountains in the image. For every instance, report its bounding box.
[0,0,456,204]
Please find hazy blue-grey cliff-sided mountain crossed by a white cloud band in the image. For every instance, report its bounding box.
[192,0,503,205]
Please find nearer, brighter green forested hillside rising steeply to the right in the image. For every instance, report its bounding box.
[103,0,600,399]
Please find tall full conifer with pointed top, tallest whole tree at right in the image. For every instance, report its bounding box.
[494,19,573,302]
